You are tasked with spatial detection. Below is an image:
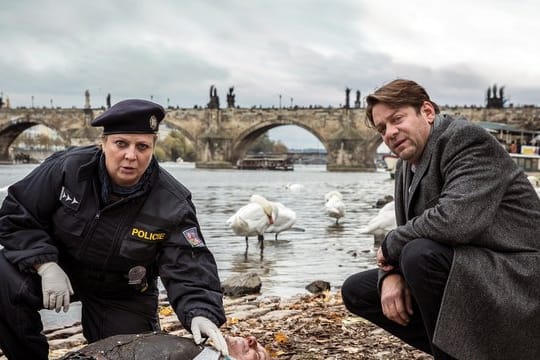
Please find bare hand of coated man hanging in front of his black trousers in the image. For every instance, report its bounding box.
[381,274,413,326]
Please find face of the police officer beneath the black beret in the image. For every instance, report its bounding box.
[102,134,155,186]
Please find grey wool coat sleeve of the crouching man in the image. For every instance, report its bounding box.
[383,122,517,264]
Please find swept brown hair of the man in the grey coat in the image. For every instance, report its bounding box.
[366,79,440,128]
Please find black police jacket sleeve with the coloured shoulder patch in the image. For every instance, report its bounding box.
[158,197,226,329]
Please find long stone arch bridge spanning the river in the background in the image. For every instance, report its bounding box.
[0,107,540,171]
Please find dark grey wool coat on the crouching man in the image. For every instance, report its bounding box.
[383,115,540,360]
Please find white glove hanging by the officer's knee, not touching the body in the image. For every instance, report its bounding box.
[37,262,73,312]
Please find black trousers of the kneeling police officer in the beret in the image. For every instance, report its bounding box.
[0,250,160,360]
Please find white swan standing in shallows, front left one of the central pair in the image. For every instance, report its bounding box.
[227,194,275,247]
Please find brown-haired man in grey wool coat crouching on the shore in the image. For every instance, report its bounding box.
[342,79,540,360]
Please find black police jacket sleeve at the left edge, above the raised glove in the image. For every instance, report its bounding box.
[0,155,62,271]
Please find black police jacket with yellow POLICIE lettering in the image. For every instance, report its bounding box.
[0,146,225,329]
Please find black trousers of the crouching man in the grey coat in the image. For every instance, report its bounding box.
[341,239,454,359]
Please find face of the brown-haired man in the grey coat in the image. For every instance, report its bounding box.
[373,101,435,164]
